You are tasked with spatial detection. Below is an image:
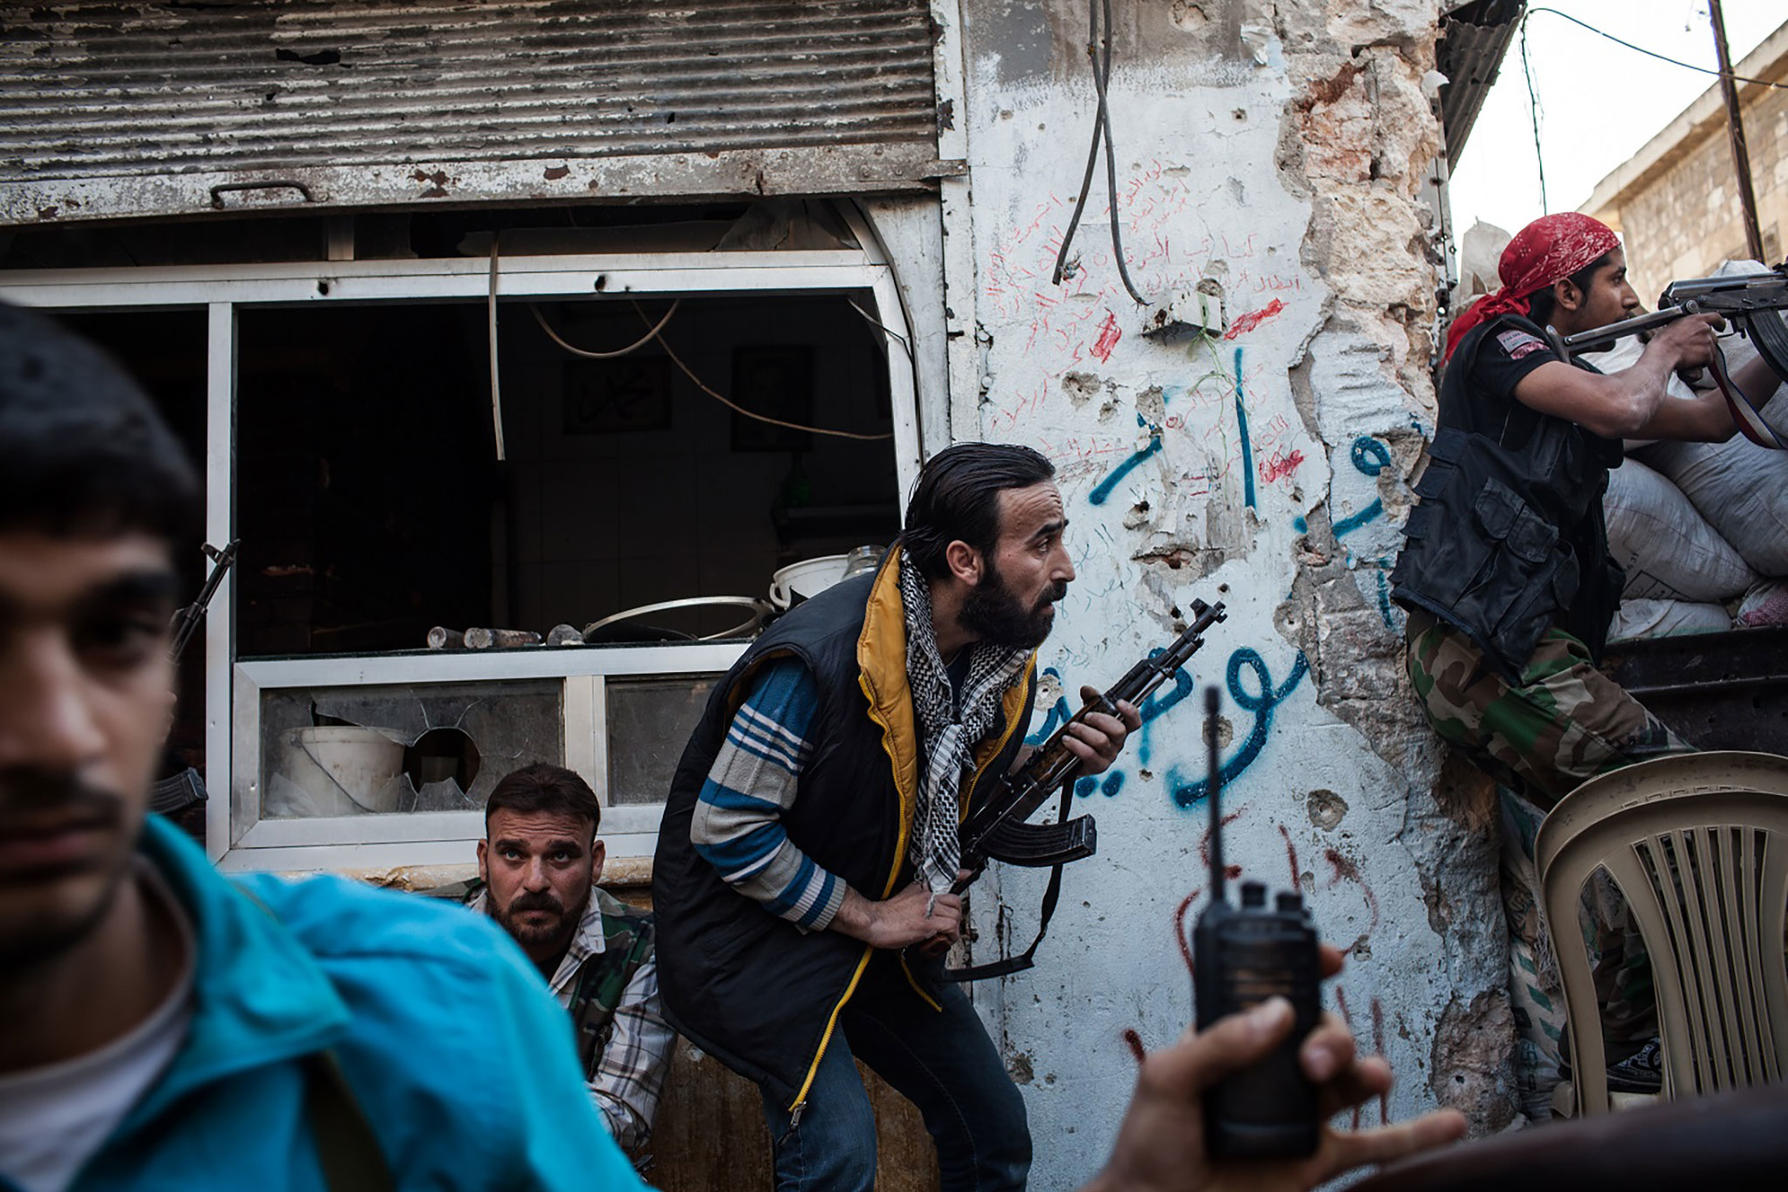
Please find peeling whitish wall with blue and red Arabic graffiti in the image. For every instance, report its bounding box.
[946,0,1511,1188]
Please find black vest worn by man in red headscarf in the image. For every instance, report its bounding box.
[1391,316,1625,681]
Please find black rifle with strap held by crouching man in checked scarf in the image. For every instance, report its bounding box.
[944,600,1228,981]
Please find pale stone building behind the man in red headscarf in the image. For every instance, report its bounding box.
[1581,23,1788,306]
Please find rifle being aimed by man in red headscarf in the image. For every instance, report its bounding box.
[1547,261,1788,450]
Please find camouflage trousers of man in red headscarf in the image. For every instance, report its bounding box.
[1405,613,1693,1063]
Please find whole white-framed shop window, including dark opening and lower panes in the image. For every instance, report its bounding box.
[10,200,942,870]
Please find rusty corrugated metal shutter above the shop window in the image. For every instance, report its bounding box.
[0,0,951,223]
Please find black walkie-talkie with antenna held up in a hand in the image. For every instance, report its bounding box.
[1193,686,1321,1158]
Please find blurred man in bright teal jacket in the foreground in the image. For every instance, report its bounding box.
[0,307,640,1192]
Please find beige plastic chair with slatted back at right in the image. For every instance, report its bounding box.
[1534,752,1788,1113]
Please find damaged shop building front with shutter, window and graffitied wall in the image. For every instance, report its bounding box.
[0,0,1516,1188]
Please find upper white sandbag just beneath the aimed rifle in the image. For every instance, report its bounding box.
[1636,319,1788,577]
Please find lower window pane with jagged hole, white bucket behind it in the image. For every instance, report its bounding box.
[261,679,565,818]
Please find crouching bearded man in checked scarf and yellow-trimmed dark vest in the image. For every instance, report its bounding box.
[653,443,1141,1188]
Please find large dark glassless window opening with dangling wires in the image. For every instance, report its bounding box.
[236,295,899,658]
